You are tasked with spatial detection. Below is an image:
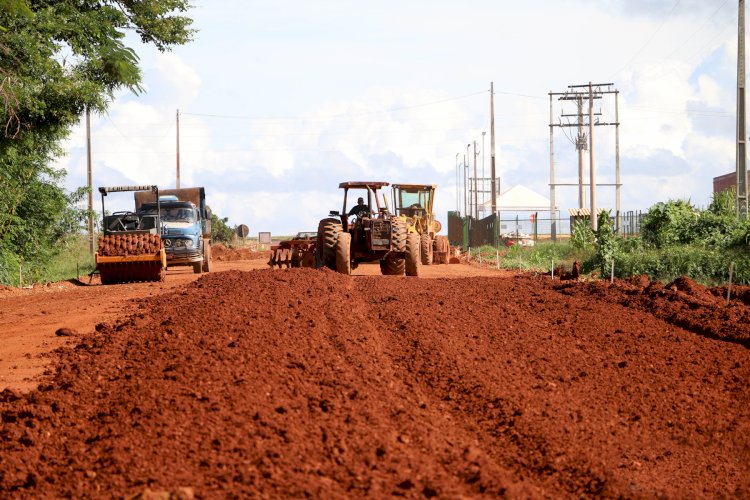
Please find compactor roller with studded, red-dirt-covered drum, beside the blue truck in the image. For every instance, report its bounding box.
[94,186,167,285]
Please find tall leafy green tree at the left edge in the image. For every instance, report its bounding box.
[0,0,193,282]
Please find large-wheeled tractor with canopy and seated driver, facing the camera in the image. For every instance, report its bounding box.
[316,181,421,276]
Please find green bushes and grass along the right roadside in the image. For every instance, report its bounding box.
[471,190,750,285]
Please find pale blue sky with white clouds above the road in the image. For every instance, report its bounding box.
[60,0,737,234]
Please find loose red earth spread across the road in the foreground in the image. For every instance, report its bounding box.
[0,259,750,498]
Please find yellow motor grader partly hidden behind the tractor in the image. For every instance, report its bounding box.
[391,184,450,265]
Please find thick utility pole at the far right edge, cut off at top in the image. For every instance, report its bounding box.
[737,0,748,220]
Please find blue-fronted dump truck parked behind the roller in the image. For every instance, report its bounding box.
[134,187,213,273]
